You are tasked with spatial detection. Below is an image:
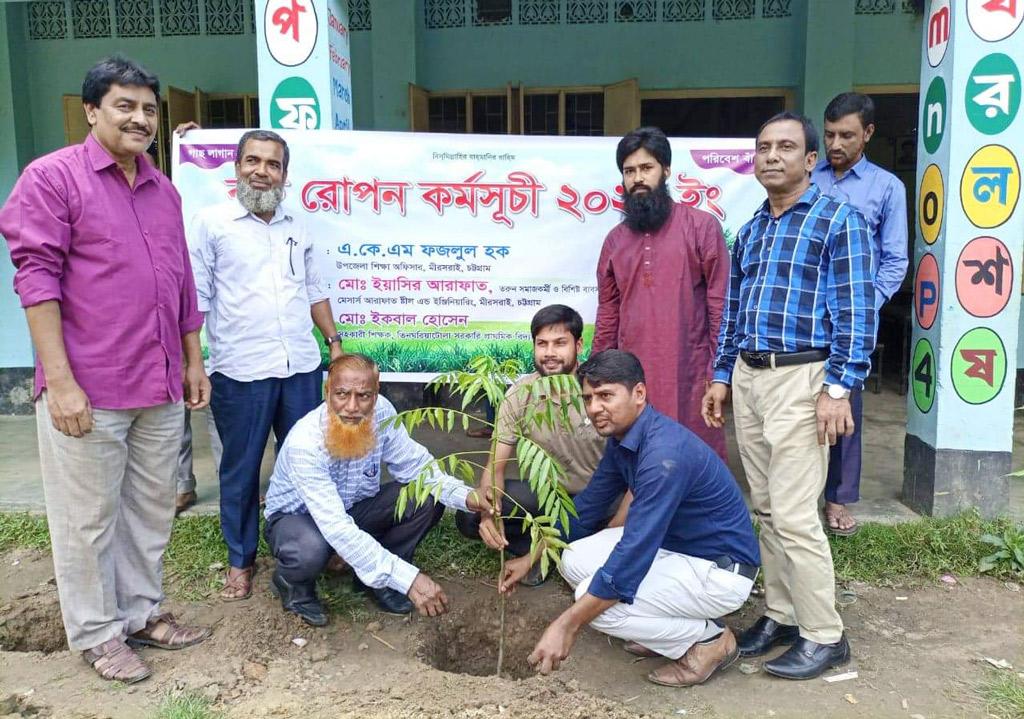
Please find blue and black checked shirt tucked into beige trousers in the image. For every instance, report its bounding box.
[714,184,877,389]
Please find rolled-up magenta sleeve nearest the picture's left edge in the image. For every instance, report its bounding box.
[0,166,71,307]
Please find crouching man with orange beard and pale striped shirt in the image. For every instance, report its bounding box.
[265,354,490,627]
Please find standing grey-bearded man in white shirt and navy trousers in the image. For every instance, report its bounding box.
[188,130,341,601]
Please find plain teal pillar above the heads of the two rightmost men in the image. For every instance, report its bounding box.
[799,0,855,123]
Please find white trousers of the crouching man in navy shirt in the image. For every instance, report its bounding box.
[558,526,754,660]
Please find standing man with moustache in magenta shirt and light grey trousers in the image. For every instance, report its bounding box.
[0,56,210,683]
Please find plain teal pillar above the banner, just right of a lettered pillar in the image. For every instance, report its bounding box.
[370,0,420,130]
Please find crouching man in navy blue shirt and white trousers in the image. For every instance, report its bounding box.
[501,349,761,686]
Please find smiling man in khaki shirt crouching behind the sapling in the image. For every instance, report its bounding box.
[456,304,614,587]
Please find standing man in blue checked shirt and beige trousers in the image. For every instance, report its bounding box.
[701,113,877,679]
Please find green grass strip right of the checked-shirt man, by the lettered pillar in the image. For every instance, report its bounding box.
[829,512,1012,582]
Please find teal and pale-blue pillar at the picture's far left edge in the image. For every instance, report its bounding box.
[0,3,35,370]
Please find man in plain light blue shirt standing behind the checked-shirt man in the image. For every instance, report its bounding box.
[811,92,907,537]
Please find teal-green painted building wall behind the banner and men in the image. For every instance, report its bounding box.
[0,0,921,367]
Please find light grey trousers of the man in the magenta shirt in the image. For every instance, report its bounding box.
[36,392,184,650]
